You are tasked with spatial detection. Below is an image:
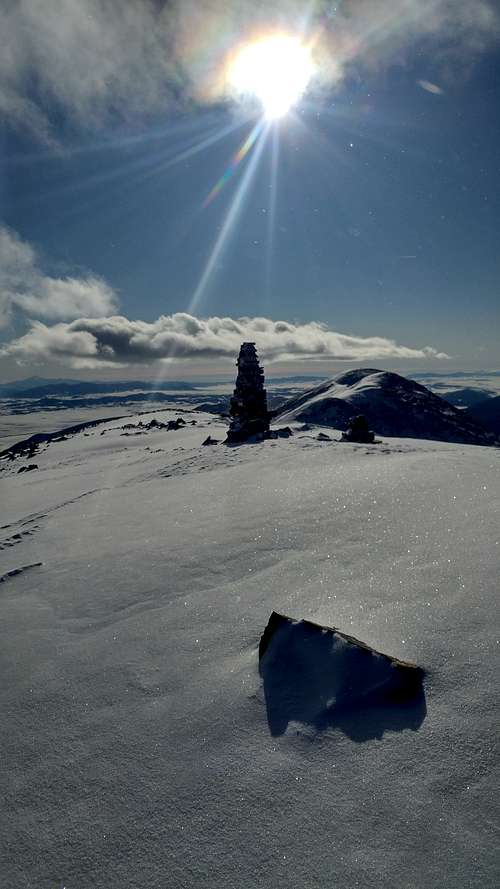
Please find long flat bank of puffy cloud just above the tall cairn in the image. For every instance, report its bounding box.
[0,312,448,368]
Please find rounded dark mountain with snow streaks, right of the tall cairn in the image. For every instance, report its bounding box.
[273,368,494,445]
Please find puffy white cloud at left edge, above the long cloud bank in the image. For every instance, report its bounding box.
[0,226,117,327]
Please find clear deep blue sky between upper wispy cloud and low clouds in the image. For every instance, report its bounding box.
[1,46,500,367]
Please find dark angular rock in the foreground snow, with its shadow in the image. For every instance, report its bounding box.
[259,611,426,740]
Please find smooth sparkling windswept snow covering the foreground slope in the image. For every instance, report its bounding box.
[0,411,500,889]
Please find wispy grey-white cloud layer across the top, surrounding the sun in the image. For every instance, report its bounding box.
[0,0,499,141]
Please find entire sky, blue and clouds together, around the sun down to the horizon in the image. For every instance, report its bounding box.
[0,0,500,379]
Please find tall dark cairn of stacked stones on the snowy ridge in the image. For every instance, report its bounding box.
[227,343,269,442]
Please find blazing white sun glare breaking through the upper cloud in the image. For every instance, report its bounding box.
[229,35,314,120]
